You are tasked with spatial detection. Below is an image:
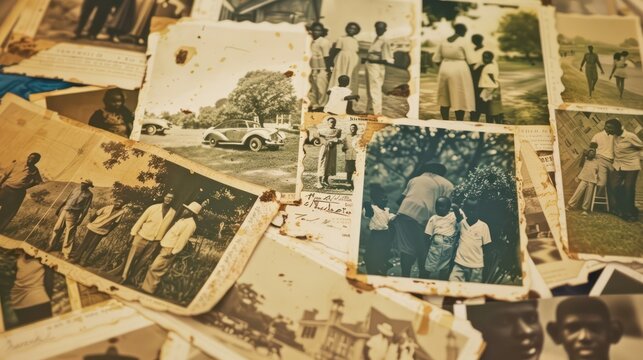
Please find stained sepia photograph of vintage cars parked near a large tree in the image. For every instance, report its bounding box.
[132,22,309,193]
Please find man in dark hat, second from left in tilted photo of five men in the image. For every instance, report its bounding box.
[47,179,94,259]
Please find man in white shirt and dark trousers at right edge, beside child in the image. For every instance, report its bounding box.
[605,119,643,221]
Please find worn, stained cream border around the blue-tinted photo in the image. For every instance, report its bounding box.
[346,119,531,300]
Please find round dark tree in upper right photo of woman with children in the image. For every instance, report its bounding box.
[498,11,542,64]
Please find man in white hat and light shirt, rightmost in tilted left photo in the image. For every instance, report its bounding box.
[141,202,201,294]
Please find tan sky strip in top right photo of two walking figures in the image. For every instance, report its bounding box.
[556,14,639,45]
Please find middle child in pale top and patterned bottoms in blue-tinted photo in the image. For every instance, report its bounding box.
[424,196,462,280]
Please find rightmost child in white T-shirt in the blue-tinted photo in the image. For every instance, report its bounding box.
[449,199,491,283]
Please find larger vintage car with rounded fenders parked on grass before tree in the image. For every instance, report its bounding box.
[202,119,286,151]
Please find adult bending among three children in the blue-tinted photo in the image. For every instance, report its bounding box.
[364,162,491,282]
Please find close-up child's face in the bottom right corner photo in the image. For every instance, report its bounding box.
[558,313,610,360]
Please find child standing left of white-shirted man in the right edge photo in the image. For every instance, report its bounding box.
[567,142,599,215]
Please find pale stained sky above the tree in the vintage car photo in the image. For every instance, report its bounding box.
[139,22,309,114]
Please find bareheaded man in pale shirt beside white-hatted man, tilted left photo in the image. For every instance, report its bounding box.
[121,193,176,282]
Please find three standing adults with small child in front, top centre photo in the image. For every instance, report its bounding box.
[309,21,394,115]
